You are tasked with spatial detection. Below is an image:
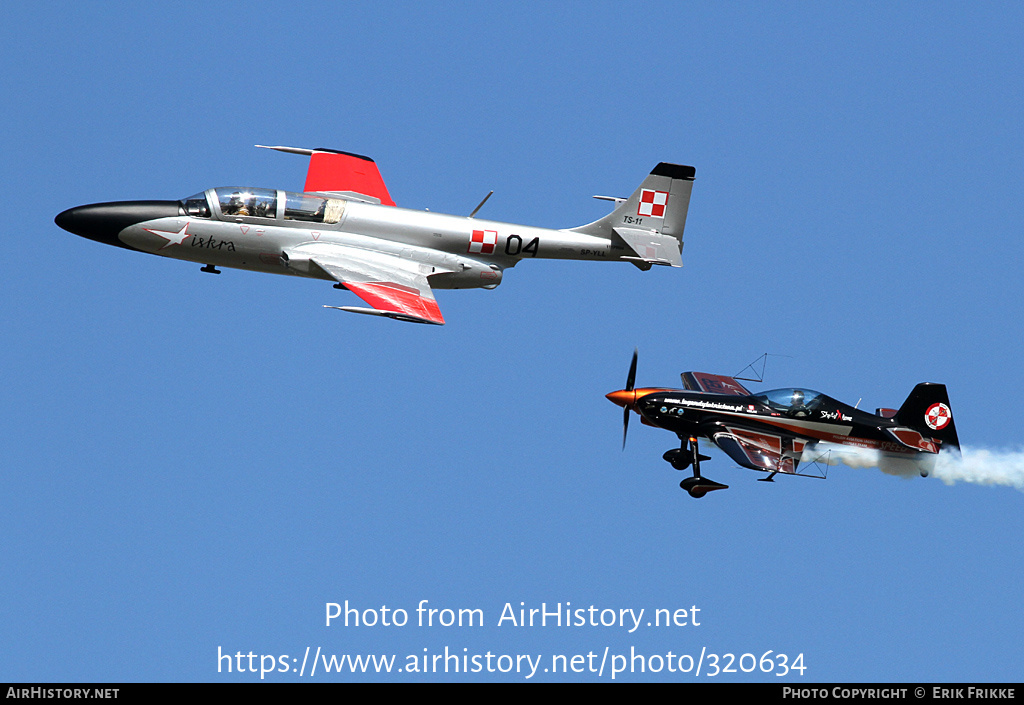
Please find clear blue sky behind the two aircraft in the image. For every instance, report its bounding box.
[0,2,1024,683]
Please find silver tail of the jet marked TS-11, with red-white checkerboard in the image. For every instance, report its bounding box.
[571,162,696,269]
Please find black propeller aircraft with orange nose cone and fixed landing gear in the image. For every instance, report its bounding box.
[607,350,959,498]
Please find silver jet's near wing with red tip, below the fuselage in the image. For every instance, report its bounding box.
[309,245,444,326]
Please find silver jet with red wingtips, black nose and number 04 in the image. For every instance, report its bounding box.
[55,144,694,325]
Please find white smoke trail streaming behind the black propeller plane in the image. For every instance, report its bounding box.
[800,443,1024,492]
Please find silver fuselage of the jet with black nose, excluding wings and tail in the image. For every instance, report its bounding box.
[56,189,628,289]
